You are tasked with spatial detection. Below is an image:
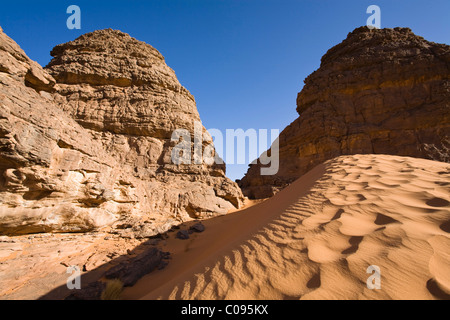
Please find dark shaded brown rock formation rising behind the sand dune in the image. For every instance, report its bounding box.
[239,27,450,198]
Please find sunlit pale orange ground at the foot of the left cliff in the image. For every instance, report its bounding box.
[0,232,147,300]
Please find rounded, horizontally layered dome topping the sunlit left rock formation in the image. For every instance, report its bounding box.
[46,30,200,139]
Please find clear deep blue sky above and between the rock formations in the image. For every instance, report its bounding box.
[0,0,450,180]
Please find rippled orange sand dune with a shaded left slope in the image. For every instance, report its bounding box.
[122,155,450,300]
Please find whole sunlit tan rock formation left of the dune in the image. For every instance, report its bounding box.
[0,30,242,235]
